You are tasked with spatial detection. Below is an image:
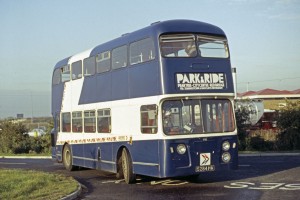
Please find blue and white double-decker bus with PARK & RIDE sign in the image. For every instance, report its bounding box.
[52,20,238,183]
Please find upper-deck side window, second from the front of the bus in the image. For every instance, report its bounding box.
[112,45,127,69]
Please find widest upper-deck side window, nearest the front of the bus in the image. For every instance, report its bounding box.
[129,38,155,65]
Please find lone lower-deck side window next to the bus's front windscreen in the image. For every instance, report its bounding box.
[141,104,157,133]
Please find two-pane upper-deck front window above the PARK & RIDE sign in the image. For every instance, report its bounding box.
[160,34,229,58]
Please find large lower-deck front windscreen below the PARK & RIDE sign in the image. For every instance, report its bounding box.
[163,99,235,134]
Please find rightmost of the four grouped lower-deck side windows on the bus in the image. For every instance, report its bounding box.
[97,109,111,133]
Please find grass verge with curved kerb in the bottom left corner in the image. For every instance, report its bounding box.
[0,169,78,200]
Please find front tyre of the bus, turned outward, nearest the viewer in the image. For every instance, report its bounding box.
[122,148,135,184]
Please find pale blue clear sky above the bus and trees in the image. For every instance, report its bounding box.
[0,0,300,118]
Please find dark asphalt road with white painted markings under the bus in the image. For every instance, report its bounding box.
[0,155,300,200]
